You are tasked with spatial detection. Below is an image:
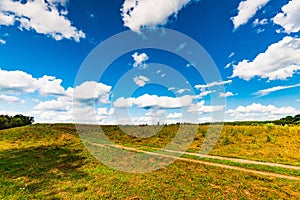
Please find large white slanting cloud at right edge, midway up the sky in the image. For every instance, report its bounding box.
[232,36,300,80]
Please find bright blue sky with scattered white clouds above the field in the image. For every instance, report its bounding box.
[0,0,300,124]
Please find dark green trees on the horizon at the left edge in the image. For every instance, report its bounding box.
[0,115,34,130]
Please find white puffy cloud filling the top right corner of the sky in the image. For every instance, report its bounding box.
[273,0,300,33]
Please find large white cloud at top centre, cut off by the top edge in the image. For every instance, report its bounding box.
[121,0,198,32]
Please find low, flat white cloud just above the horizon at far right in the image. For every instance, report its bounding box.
[226,103,299,120]
